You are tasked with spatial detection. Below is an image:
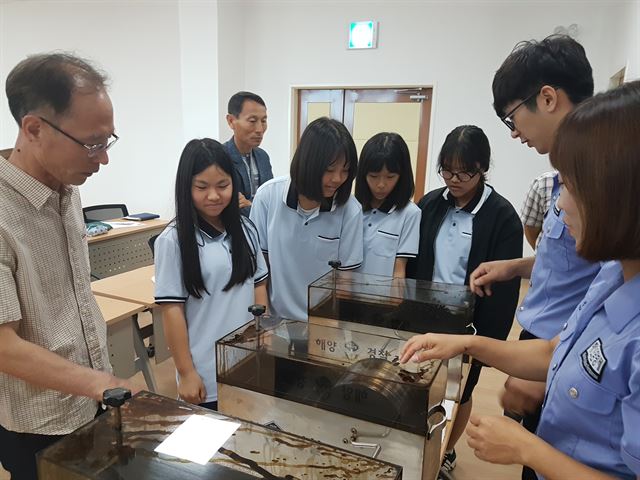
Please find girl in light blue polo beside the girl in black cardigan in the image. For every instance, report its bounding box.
[355,133,421,278]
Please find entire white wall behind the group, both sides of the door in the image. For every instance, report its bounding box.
[0,0,640,229]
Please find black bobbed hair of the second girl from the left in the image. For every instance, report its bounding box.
[290,117,358,205]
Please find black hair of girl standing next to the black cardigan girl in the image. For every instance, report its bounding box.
[355,132,415,212]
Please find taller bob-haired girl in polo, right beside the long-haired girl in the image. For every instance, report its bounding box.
[250,117,362,320]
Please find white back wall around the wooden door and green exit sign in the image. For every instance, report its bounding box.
[218,0,628,258]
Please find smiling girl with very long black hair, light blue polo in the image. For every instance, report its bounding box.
[155,138,268,409]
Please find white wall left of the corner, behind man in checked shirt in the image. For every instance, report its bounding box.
[0,0,218,217]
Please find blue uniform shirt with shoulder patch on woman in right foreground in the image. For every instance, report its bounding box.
[537,262,640,480]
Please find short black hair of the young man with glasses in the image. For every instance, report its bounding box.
[492,35,593,117]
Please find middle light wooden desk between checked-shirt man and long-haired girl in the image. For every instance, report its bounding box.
[91,265,170,363]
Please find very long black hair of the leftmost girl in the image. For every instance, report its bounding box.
[175,138,257,298]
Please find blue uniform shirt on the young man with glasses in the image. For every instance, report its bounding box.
[516,175,600,340]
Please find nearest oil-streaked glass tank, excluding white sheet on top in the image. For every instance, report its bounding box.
[38,392,402,480]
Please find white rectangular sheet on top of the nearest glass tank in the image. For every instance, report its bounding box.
[155,415,240,465]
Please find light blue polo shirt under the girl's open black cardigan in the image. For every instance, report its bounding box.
[433,185,493,285]
